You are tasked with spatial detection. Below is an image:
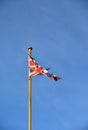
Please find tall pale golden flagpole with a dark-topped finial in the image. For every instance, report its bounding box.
[28,47,32,130]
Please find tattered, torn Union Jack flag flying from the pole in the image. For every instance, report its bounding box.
[28,55,61,81]
